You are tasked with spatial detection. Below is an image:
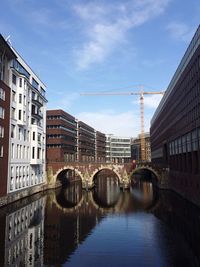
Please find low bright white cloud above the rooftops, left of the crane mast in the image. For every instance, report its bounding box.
[76,110,140,137]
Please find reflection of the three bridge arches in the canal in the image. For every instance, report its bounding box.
[51,178,157,214]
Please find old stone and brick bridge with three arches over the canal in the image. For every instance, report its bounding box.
[47,162,168,189]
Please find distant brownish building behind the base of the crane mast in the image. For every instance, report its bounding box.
[131,133,151,161]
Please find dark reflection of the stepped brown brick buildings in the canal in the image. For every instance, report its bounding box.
[44,189,102,266]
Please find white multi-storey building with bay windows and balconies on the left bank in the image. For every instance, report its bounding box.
[7,48,47,193]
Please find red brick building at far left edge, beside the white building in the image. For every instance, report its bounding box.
[0,35,16,197]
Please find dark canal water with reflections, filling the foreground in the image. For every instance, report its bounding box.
[0,175,200,267]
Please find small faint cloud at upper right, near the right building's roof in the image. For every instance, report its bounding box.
[167,22,194,42]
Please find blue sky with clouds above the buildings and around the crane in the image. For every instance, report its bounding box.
[0,0,200,136]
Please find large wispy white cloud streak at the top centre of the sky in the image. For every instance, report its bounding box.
[74,0,170,70]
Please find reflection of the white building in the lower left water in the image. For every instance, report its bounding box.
[0,197,45,267]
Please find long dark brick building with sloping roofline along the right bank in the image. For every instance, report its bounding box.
[150,24,200,204]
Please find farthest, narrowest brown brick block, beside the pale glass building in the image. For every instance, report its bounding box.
[95,131,106,162]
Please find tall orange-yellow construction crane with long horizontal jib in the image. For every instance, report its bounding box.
[81,86,165,161]
